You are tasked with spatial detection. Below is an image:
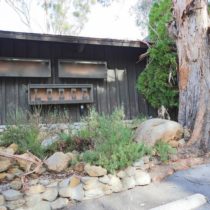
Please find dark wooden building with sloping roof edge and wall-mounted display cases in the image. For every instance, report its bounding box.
[0,31,152,124]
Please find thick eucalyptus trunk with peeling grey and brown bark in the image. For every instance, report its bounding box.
[169,0,210,149]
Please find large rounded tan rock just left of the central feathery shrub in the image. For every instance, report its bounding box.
[45,152,70,172]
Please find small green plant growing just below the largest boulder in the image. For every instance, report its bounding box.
[154,141,176,163]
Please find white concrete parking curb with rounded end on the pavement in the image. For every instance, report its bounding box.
[150,194,207,210]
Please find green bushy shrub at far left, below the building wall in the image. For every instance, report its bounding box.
[0,125,44,158]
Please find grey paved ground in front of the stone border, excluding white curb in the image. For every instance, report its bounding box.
[66,164,210,210]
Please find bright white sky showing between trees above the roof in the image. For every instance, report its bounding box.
[0,0,146,40]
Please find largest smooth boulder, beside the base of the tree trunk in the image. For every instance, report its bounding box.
[134,118,183,146]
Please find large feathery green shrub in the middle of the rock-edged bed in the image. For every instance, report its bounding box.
[83,109,150,172]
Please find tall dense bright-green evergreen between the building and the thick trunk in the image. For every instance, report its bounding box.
[137,0,178,108]
